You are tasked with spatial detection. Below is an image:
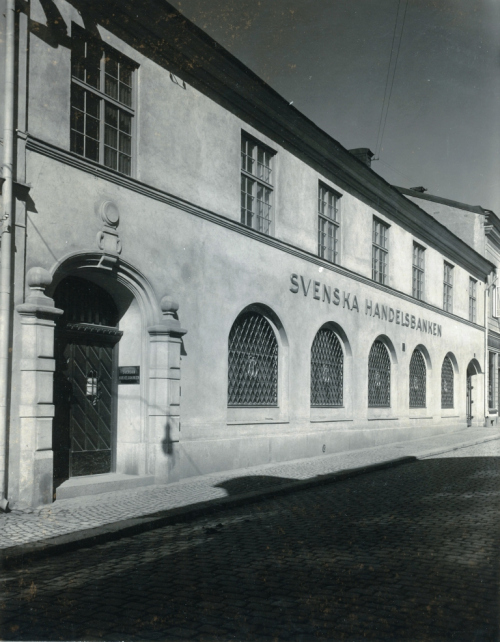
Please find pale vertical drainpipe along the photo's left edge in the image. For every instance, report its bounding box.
[0,0,16,511]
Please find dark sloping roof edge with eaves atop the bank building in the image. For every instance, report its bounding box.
[78,0,494,278]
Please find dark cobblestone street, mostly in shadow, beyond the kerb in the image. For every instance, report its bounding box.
[0,440,500,641]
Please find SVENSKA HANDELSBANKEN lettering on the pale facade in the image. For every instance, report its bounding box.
[290,274,442,337]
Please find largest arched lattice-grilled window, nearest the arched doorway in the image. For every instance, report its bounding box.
[228,312,278,406]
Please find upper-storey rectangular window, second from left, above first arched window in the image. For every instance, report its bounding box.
[241,135,274,234]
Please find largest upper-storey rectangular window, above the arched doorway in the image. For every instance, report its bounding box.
[71,29,136,176]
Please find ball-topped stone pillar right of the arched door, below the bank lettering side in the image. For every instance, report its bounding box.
[148,296,186,483]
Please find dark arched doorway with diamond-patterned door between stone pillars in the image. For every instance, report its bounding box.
[52,277,122,487]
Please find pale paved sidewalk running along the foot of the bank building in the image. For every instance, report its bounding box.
[0,428,500,555]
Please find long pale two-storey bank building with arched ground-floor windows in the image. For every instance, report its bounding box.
[0,0,493,505]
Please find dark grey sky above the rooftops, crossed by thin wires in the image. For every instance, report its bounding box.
[175,0,500,215]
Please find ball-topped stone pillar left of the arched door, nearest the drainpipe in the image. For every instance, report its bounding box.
[16,268,63,506]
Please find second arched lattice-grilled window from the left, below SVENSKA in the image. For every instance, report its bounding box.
[311,328,344,406]
